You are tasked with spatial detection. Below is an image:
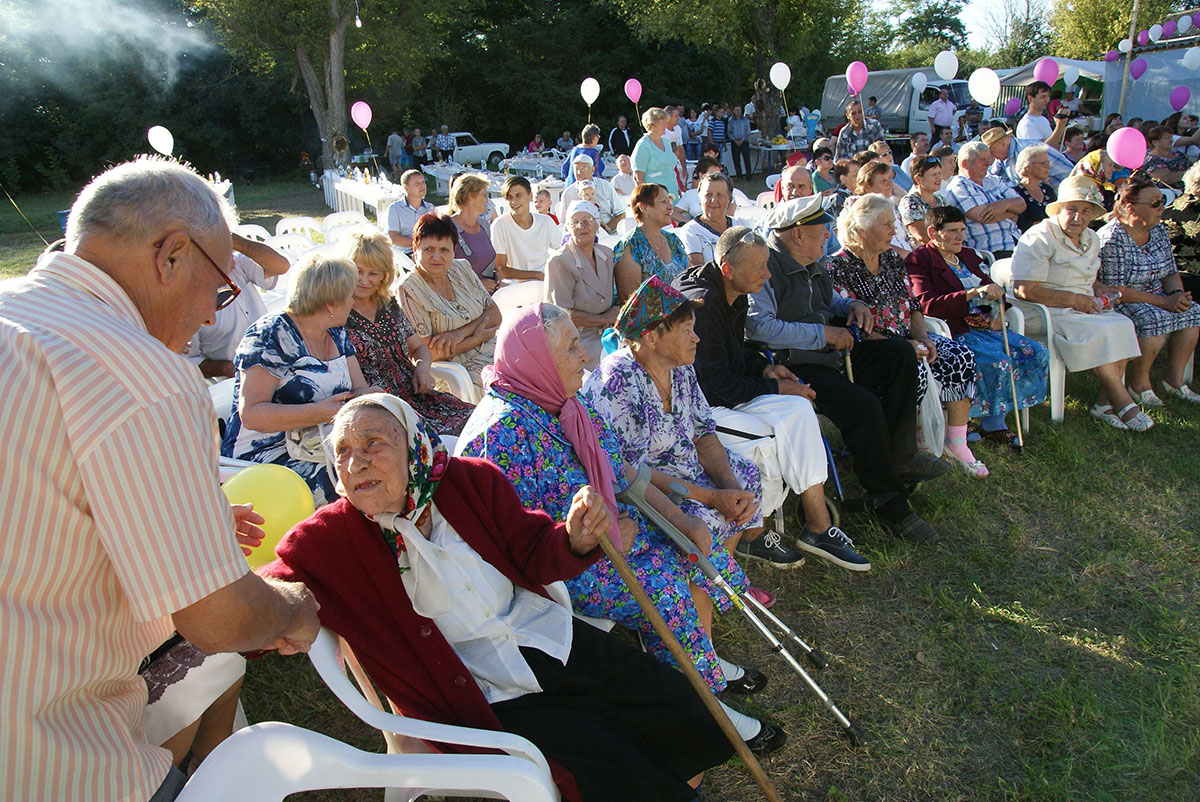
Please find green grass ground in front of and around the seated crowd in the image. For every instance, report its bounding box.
[9,175,1200,802]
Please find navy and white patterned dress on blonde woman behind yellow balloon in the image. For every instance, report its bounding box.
[221,312,354,507]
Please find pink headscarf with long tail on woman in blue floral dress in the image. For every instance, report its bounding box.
[485,304,623,549]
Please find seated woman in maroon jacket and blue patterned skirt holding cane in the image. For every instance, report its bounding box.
[905,207,1050,444]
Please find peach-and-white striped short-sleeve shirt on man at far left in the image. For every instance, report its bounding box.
[0,253,247,801]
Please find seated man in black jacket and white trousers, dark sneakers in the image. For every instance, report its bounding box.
[674,226,871,571]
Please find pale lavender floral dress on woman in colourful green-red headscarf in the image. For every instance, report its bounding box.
[583,347,762,542]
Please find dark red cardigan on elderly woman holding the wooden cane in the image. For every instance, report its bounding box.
[262,457,600,800]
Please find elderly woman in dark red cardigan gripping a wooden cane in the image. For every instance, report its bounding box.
[264,393,730,802]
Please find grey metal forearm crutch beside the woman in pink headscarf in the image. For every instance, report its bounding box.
[617,465,865,747]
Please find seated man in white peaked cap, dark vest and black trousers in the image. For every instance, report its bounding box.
[746,196,949,545]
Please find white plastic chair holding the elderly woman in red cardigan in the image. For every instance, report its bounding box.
[304,628,559,802]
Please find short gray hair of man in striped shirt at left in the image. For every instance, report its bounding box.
[66,156,238,252]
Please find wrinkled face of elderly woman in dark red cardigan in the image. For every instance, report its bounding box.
[334,407,408,515]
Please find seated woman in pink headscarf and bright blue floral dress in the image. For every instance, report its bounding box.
[458,304,786,754]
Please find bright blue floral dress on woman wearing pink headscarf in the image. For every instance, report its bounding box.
[458,387,745,692]
